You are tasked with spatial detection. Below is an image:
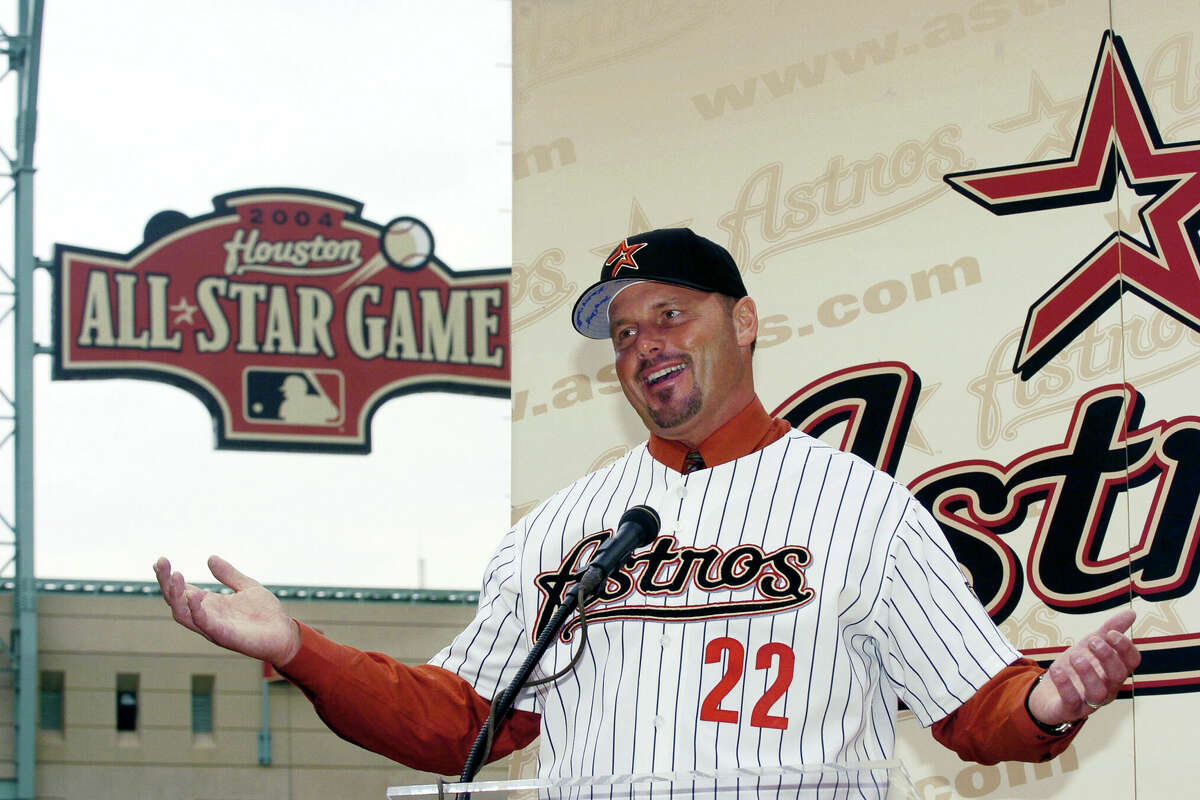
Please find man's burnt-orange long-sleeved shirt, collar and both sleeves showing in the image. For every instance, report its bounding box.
[278,399,1080,775]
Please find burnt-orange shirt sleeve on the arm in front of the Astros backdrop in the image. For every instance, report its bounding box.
[931,658,1082,764]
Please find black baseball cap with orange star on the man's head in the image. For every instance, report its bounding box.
[571,228,746,339]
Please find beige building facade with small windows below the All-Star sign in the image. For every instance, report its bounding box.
[0,581,508,800]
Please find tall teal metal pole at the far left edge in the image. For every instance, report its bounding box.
[12,0,42,800]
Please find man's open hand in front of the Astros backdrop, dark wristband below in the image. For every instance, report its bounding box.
[1030,610,1141,726]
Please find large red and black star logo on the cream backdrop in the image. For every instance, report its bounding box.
[944,31,1200,380]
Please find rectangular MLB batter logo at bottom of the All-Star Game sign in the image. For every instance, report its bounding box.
[242,367,346,427]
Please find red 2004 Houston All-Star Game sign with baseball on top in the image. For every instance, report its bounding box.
[54,188,510,453]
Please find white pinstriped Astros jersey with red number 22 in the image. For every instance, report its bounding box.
[431,431,1019,777]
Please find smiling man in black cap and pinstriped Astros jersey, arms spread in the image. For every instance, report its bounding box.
[155,229,1140,776]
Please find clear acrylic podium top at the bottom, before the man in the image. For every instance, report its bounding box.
[388,759,919,800]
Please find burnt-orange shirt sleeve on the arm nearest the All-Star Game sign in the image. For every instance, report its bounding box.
[277,621,541,775]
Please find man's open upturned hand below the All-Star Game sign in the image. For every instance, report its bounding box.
[154,555,300,667]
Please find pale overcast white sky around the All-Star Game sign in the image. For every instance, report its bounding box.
[10,0,511,589]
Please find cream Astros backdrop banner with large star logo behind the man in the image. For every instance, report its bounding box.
[511,0,1200,800]
